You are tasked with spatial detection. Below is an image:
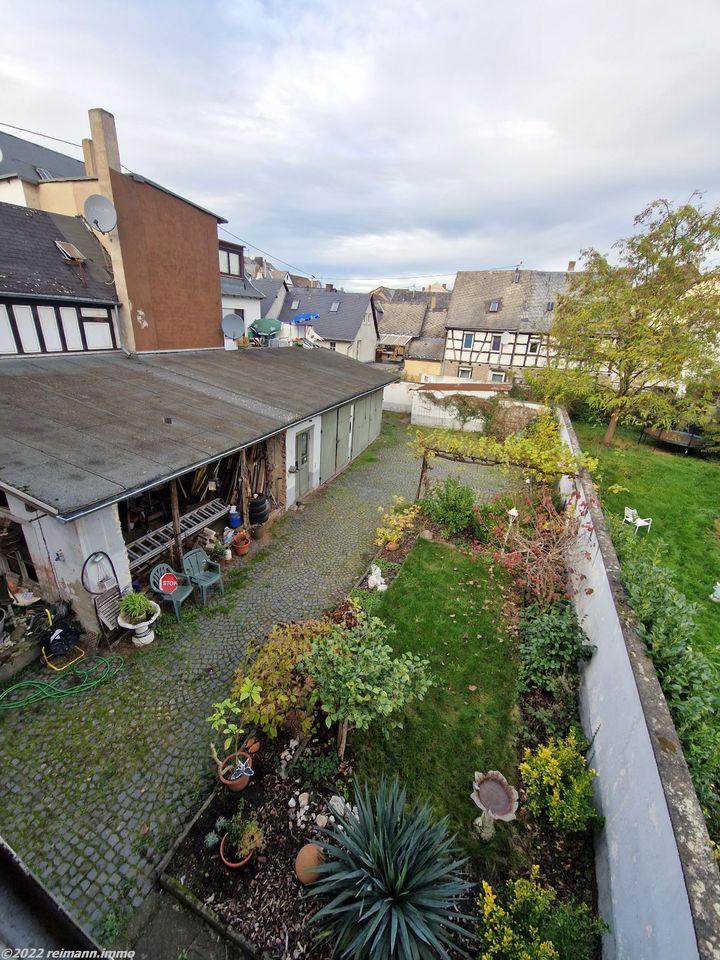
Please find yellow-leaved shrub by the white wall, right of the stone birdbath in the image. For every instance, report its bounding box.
[519,730,600,832]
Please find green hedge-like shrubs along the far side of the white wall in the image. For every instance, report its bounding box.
[610,520,720,840]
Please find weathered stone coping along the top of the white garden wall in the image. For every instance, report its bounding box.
[558,408,720,960]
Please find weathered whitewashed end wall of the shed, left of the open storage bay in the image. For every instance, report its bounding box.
[7,494,131,633]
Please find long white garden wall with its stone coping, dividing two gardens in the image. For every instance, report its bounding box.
[559,410,720,960]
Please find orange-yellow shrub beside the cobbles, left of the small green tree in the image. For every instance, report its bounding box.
[233,620,332,738]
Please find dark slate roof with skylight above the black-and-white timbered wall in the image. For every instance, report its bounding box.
[0,203,117,303]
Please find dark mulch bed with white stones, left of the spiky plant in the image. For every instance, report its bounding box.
[166,738,349,960]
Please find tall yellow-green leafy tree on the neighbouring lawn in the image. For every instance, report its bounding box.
[528,201,720,443]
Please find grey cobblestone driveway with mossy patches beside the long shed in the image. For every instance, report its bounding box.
[0,416,513,936]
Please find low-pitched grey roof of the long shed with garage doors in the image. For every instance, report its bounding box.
[0,347,398,520]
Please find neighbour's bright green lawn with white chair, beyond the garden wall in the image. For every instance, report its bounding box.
[574,422,720,668]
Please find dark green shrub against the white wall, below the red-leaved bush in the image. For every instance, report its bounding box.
[520,600,592,692]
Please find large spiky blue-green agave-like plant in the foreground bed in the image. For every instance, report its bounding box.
[308,778,472,960]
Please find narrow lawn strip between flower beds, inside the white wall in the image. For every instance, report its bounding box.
[352,540,517,862]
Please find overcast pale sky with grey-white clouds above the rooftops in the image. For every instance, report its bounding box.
[0,0,720,289]
